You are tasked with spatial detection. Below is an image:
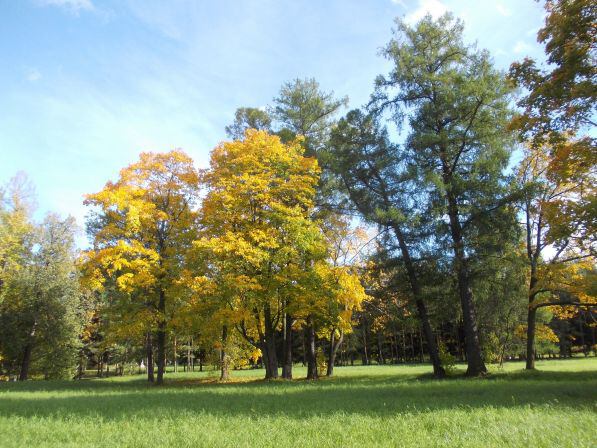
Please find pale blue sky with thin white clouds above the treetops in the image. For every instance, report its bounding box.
[0,0,544,245]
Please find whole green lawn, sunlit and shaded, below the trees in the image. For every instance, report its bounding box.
[0,358,597,448]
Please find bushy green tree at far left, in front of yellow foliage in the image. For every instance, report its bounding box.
[0,215,85,381]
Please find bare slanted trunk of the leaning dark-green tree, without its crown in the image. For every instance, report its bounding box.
[394,226,446,378]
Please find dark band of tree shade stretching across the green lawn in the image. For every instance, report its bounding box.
[0,372,597,420]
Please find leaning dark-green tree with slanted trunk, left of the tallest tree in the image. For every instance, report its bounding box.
[329,110,445,377]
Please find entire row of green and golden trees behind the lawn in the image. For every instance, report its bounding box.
[0,0,597,383]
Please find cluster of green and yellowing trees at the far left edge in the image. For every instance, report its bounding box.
[0,175,86,380]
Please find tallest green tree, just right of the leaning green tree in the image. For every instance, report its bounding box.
[371,14,512,376]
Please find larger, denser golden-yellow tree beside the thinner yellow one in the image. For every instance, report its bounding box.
[194,130,325,378]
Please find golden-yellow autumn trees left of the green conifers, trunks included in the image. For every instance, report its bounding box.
[83,130,365,383]
